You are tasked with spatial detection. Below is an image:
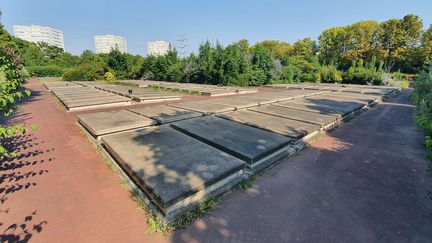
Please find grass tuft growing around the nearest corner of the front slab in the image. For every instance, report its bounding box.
[130,190,219,235]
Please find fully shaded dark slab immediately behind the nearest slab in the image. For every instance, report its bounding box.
[171,116,292,165]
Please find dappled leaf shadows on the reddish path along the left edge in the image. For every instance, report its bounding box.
[0,85,50,242]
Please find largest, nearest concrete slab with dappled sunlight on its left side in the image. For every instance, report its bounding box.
[102,125,245,214]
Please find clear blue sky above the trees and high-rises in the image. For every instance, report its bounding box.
[0,0,432,55]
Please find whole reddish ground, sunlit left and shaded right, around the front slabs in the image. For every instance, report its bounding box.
[0,80,432,242]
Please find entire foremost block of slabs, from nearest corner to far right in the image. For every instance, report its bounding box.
[73,86,384,220]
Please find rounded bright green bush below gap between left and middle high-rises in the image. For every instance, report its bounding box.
[63,64,106,81]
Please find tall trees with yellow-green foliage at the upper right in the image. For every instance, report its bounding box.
[318,14,426,73]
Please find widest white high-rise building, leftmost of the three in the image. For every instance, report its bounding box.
[13,25,64,50]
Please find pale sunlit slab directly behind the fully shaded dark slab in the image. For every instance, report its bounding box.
[217,110,321,139]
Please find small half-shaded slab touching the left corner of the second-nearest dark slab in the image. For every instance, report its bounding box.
[129,105,202,124]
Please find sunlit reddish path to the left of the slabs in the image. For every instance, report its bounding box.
[0,80,167,242]
